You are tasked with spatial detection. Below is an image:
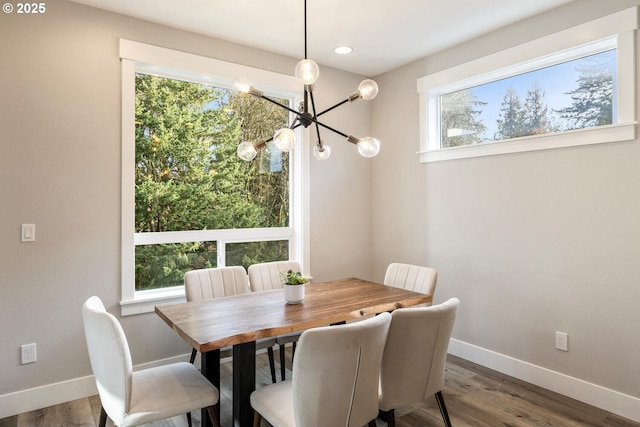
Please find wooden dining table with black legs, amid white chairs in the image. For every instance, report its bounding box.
[155,278,432,427]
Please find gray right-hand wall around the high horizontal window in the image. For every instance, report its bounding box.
[372,0,640,397]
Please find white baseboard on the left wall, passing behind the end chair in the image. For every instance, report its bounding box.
[0,355,189,419]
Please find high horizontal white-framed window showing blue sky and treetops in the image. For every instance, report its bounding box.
[418,8,637,162]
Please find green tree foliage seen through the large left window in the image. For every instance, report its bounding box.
[135,75,289,290]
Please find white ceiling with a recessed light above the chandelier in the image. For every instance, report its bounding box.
[70,0,572,77]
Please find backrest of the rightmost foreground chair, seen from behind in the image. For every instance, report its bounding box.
[380,298,460,411]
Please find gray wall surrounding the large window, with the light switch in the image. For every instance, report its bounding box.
[0,1,371,404]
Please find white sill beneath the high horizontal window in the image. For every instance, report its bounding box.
[418,122,636,163]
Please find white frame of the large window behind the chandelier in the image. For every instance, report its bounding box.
[120,39,310,316]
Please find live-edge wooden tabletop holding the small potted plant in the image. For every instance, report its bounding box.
[155,278,432,353]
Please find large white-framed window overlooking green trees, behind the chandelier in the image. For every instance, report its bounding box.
[121,40,308,315]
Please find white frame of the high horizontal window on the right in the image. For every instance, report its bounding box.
[417,7,638,163]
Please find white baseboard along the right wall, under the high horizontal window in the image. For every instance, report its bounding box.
[449,339,640,422]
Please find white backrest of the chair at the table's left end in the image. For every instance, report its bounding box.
[82,296,133,425]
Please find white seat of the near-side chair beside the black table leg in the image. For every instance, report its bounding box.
[251,380,296,427]
